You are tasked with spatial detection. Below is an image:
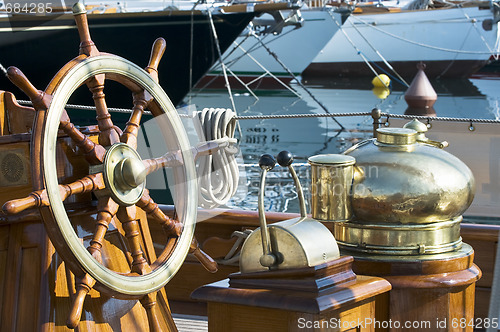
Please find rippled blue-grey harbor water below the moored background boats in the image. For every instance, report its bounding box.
[185,74,500,212]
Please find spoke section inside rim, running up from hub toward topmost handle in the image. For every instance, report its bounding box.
[87,74,121,146]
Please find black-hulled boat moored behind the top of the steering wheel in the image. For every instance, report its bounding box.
[0,1,296,107]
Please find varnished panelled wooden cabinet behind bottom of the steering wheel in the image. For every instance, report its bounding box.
[0,215,179,332]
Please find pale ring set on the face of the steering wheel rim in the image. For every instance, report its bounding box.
[42,55,197,297]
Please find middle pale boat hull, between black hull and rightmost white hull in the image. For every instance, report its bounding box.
[198,6,350,88]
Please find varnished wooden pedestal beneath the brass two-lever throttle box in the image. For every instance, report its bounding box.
[192,256,390,332]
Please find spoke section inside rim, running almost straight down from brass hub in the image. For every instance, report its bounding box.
[117,205,151,275]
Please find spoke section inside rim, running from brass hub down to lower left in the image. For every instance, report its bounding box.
[87,197,119,264]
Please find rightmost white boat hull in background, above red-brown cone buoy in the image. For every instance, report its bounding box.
[303,7,498,79]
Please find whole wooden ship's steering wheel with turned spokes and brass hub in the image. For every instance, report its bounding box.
[4,4,216,327]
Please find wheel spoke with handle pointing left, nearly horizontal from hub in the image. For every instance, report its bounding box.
[2,173,106,214]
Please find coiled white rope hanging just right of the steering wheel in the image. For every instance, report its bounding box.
[195,108,239,209]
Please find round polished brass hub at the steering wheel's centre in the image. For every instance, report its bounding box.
[104,143,146,206]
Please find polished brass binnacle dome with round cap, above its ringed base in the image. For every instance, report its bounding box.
[345,128,475,224]
